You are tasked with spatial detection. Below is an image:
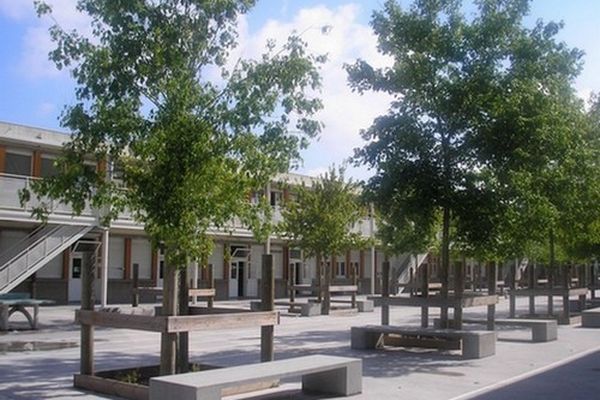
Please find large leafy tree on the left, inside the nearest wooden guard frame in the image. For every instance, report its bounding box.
[23,0,324,374]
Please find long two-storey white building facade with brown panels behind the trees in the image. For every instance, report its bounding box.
[0,122,405,304]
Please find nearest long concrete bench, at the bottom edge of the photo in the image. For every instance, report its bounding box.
[149,355,362,400]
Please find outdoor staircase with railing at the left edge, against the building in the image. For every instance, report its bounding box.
[0,225,94,294]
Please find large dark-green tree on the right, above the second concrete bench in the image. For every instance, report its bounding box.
[346,0,581,320]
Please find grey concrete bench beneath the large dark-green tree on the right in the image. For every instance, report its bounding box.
[350,325,496,359]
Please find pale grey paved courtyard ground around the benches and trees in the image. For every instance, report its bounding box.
[0,299,600,400]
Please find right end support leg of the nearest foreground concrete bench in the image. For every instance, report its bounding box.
[302,360,362,396]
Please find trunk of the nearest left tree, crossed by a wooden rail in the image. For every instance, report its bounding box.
[160,265,179,375]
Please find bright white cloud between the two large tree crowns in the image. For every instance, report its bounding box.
[239,4,392,177]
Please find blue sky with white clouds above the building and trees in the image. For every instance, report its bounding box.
[0,0,600,179]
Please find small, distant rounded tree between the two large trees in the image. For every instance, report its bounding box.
[279,168,367,314]
